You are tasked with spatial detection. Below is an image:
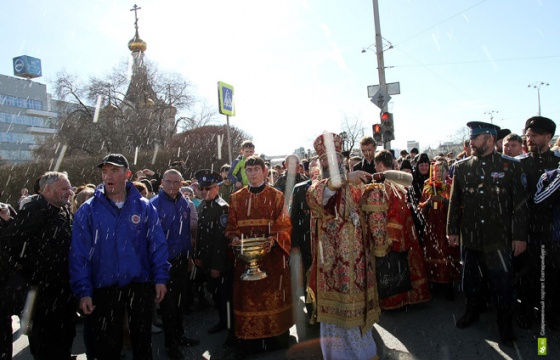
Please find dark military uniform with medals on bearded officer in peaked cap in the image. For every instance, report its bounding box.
[447,152,528,340]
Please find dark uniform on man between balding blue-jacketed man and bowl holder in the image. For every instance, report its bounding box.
[194,195,233,330]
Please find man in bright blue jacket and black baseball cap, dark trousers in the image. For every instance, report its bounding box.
[69,154,169,360]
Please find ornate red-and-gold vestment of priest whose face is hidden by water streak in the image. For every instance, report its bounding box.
[307,179,381,333]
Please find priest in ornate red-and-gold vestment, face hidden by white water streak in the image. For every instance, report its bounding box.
[307,133,380,359]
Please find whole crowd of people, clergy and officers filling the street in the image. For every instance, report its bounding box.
[0,116,560,359]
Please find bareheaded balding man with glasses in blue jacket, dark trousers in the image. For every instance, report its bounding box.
[150,169,199,360]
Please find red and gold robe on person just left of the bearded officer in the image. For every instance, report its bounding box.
[419,180,461,283]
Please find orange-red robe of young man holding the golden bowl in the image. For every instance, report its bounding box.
[226,185,294,339]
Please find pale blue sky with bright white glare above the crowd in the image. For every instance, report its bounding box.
[0,0,560,155]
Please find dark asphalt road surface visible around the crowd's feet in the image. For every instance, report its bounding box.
[6,250,560,360]
